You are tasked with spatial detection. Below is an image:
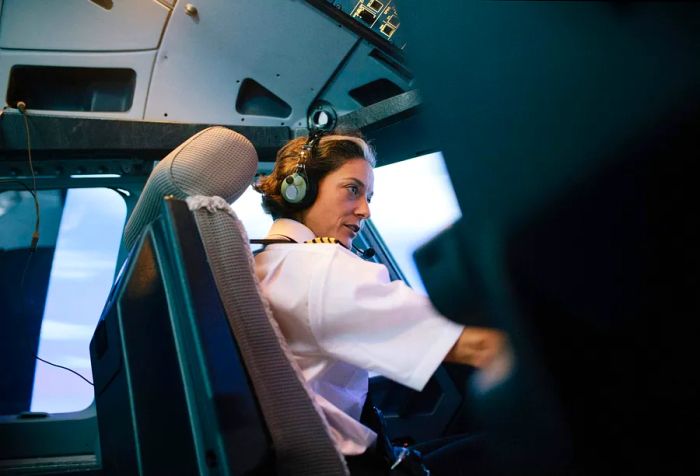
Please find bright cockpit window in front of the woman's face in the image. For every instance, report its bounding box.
[371,152,461,293]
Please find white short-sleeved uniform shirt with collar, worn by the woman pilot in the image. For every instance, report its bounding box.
[255,219,463,455]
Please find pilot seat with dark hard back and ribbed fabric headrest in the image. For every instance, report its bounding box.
[90,127,349,475]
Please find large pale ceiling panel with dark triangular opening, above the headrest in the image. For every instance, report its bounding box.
[145,0,356,127]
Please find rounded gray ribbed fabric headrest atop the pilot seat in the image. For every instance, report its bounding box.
[124,126,258,253]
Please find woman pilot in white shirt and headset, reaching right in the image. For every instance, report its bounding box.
[256,134,504,469]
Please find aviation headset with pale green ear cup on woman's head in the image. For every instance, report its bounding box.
[280,100,338,208]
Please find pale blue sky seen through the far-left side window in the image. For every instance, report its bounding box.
[31,188,126,413]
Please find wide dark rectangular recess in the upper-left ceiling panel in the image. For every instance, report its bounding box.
[6,66,136,112]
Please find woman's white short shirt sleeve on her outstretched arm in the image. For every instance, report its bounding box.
[309,249,464,390]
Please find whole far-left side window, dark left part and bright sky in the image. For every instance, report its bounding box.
[0,188,126,414]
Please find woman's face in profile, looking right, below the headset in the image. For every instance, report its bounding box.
[301,158,374,248]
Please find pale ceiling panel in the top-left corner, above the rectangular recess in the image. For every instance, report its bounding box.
[0,0,170,51]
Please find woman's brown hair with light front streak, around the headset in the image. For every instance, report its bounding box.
[253,132,376,219]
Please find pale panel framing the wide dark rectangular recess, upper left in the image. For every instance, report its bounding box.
[0,50,156,119]
